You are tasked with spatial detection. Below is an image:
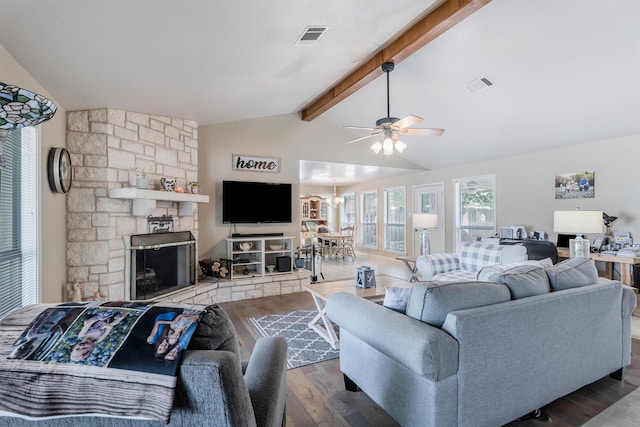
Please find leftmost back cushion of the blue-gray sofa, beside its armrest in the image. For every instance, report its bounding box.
[406,282,511,328]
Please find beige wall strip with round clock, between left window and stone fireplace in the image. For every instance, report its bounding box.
[0,45,67,302]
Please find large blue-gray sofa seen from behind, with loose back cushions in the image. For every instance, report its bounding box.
[327,258,636,427]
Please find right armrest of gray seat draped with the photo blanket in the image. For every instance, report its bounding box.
[244,336,287,427]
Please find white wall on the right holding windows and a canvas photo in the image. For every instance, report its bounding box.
[342,135,640,251]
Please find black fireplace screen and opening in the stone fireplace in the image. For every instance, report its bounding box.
[131,231,196,299]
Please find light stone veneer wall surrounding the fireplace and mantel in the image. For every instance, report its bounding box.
[67,108,198,300]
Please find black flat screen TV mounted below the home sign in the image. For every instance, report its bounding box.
[222,181,292,224]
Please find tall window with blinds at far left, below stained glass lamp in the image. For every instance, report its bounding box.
[0,127,39,318]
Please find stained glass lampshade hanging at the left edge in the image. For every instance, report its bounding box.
[0,82,57,167]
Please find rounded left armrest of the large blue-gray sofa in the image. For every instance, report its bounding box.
[327,292,458,381]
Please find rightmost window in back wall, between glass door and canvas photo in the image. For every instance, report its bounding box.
[454,175,496,247]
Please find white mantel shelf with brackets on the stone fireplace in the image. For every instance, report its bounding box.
[109,187,209,216]
